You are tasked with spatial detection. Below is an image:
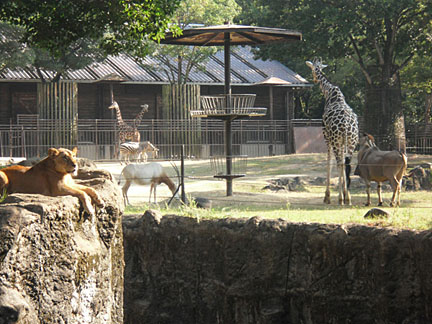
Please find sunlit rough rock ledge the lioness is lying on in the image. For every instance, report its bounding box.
[0,169,124,324]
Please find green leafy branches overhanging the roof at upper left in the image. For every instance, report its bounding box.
[0,0,180,80]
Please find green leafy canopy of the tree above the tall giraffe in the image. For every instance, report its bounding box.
[238,0,432,123]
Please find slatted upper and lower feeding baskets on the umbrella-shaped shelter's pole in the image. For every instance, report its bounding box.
[190,94,267,196]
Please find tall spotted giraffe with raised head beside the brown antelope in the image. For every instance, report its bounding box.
[306,59,358,205]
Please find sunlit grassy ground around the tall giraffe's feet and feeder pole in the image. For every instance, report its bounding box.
[121,154,432,230]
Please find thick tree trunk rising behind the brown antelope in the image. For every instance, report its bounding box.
[364,67,406,152]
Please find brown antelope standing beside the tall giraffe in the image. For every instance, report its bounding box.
[354,133,408,206]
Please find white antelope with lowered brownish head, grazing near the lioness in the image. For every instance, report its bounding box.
[118,162,177,204]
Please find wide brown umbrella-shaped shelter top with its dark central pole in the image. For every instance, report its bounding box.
[161,23,302,196]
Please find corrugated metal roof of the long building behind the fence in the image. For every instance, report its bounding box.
[0,46,309,86]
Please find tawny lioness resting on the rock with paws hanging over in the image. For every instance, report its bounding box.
[0,147,104,216]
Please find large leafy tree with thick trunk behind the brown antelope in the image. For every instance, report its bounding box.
[239,0,432,147]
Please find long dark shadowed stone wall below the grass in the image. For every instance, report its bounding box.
[123,211,432,324]
